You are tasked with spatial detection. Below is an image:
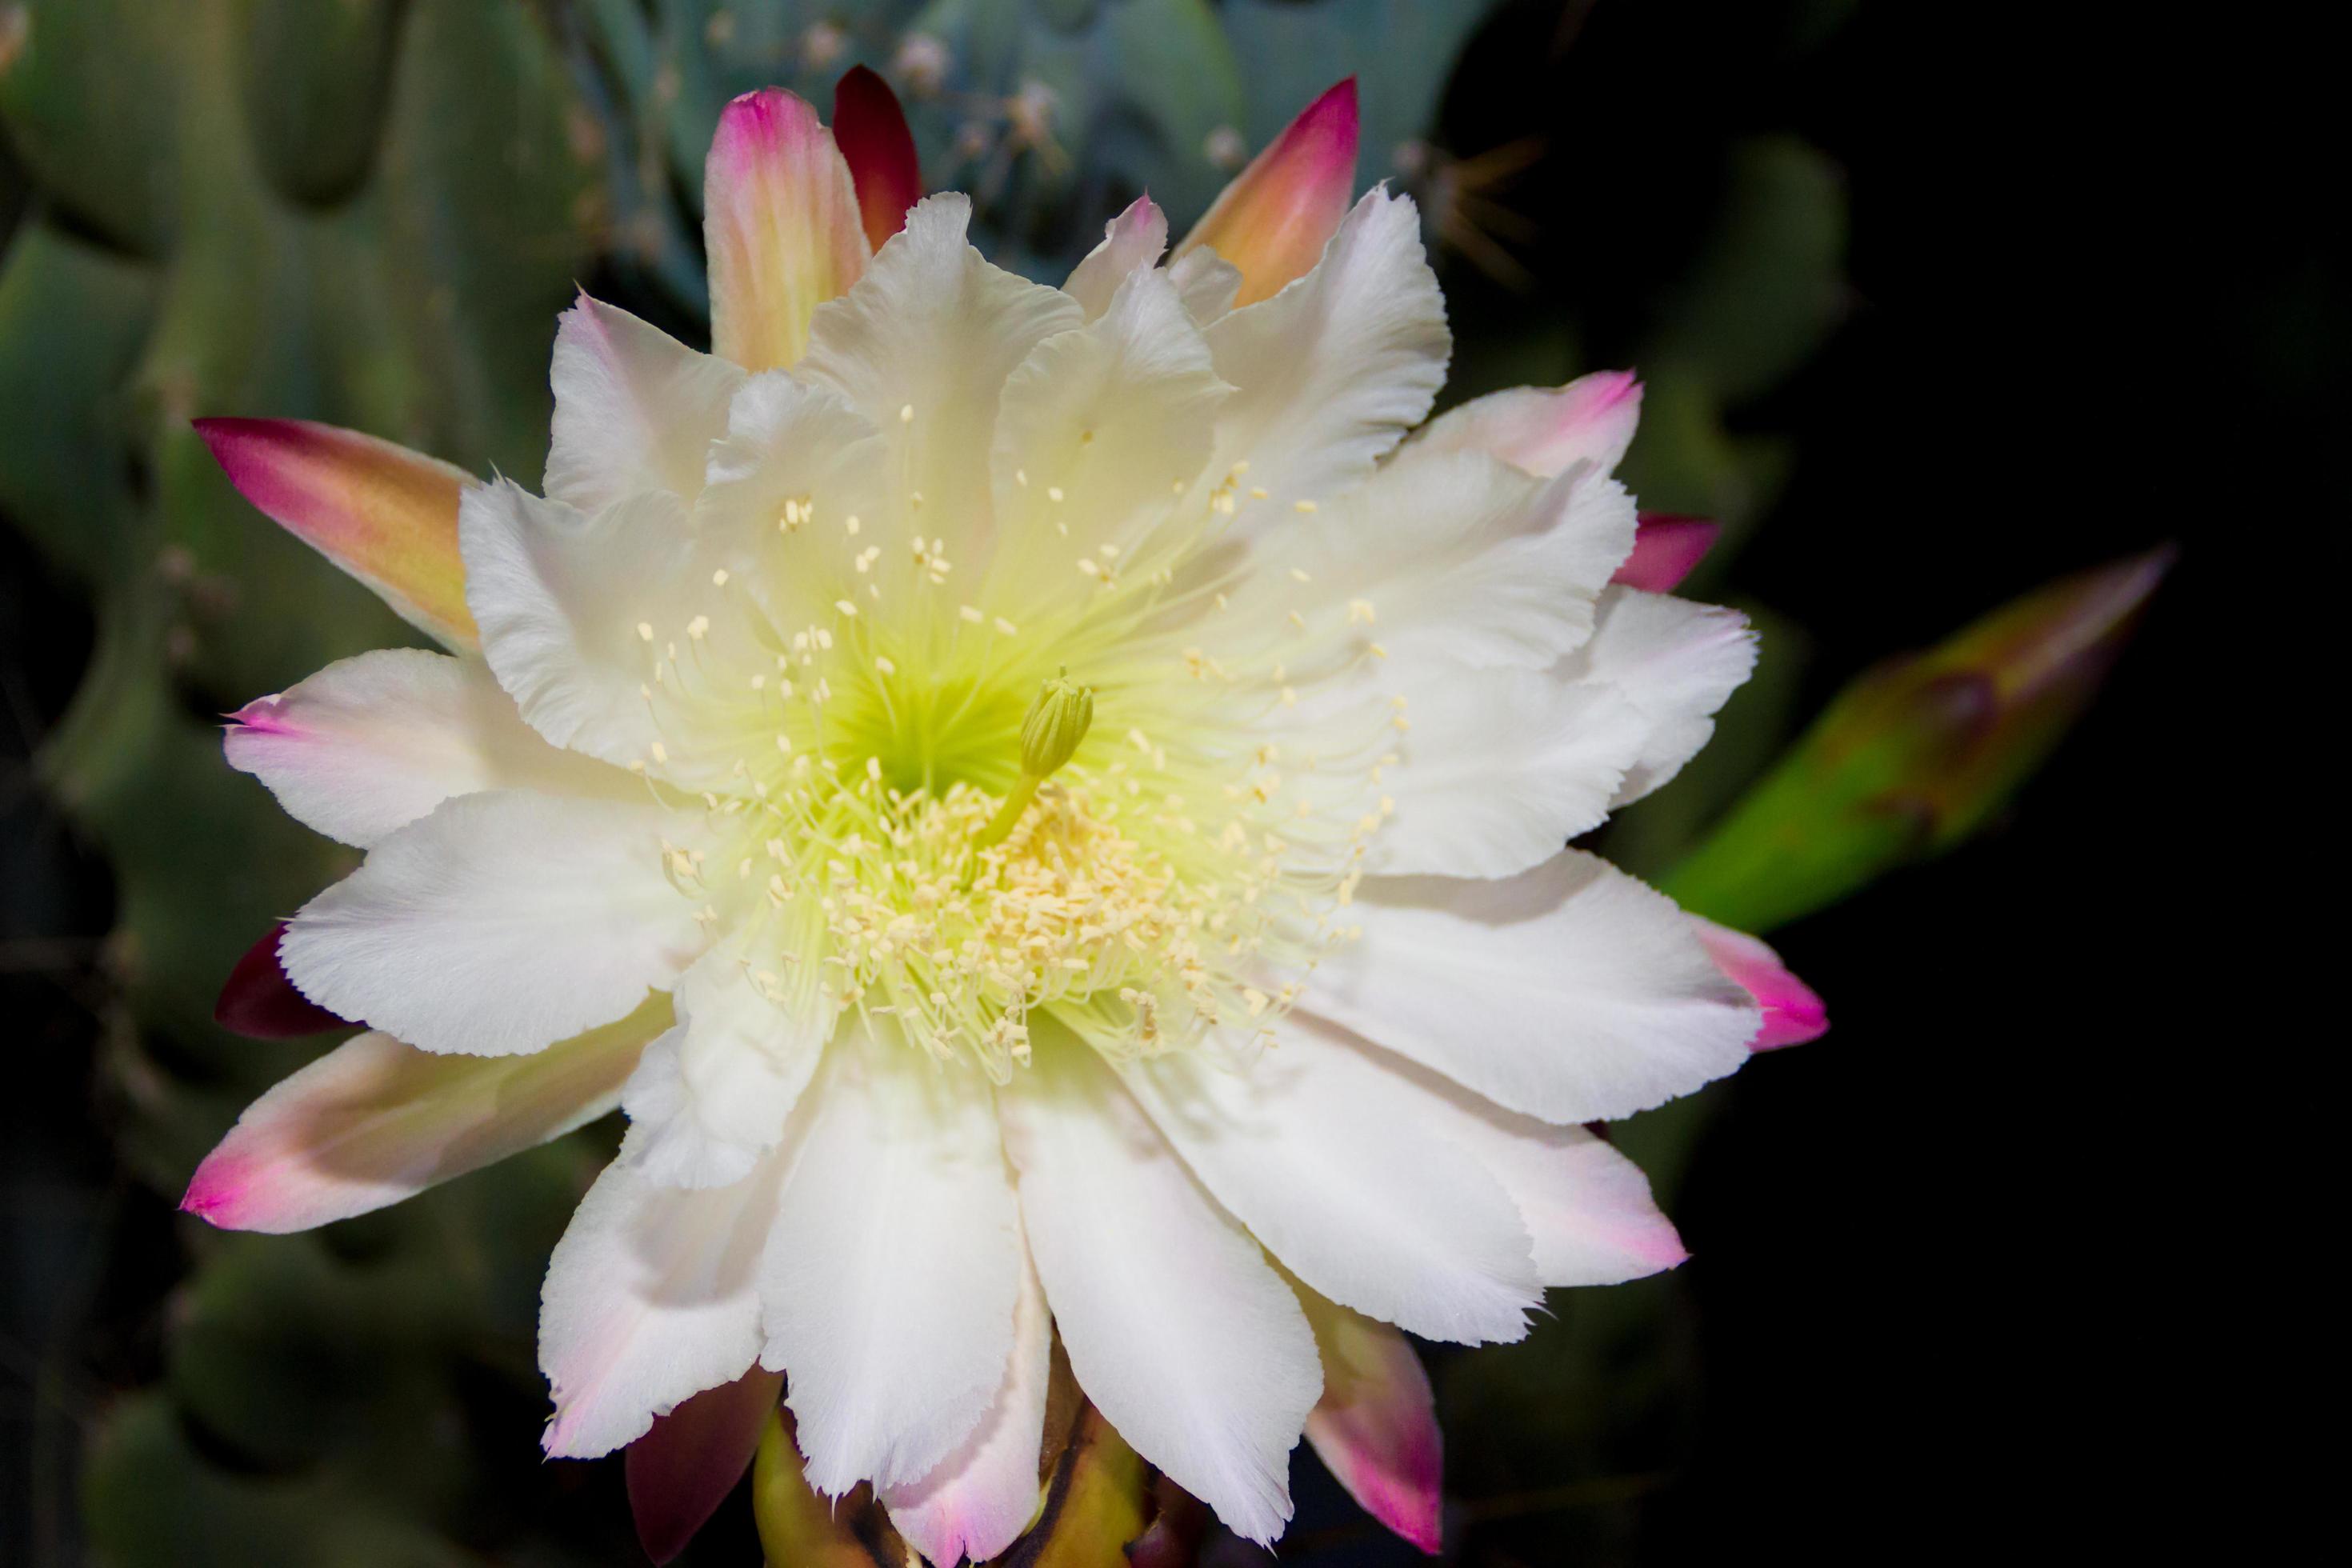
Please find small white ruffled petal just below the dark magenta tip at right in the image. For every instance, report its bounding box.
[1562,588,1757,806]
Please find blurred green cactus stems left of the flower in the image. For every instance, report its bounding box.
[0,0,602,1566]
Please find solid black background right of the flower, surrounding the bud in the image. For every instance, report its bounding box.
[1449,0,2323,1563]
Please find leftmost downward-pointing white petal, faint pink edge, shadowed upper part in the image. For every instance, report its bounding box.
[538,1145,790,1460]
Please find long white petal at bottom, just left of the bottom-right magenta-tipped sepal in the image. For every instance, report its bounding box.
[1000,1037,1322,1542]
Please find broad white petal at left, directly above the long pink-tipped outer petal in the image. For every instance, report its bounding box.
[278,790,703,1055]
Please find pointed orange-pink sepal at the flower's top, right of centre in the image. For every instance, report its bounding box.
[1176,75,1362,306]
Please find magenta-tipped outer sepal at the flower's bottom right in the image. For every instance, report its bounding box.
[1298,1290,1444,1554]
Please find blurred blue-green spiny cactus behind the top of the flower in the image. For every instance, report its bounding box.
[571,0,1494,310]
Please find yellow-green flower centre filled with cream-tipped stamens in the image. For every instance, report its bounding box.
[635,411,1404,1082]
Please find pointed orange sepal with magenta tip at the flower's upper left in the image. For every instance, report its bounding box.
[195,418,475,651]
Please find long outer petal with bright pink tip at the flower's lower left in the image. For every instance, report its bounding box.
[178,1002,668,1234]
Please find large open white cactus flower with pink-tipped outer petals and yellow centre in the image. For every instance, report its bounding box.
[186,80,1806,1563]
